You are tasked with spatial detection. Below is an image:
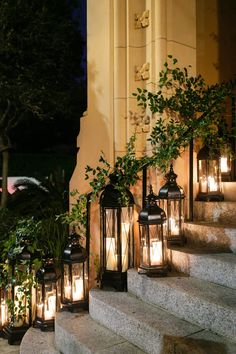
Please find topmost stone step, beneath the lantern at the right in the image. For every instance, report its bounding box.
[193,201,236,225]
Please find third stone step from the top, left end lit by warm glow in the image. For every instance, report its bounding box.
[168,247,236,289]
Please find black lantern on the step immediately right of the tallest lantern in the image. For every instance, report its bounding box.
[138,187,168,277]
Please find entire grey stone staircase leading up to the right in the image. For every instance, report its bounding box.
[20,202,236,354]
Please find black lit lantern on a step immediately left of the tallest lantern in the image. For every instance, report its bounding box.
[61,231,89,312]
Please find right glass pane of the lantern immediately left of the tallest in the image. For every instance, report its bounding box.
[72,263,84,301]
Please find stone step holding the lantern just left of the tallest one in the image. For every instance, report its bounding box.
[55,312,145,354]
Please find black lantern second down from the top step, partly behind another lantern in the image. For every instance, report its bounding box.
[158,164,184,246]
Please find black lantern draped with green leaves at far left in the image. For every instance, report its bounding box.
[3,245,32,344]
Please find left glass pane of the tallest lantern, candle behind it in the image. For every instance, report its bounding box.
[105,209,118,271]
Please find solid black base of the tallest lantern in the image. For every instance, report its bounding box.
[101,270,127,291]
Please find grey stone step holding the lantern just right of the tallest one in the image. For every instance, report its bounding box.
[128,269,236,342]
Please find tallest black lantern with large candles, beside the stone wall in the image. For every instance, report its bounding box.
[100,175,134,291]
